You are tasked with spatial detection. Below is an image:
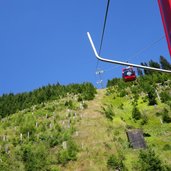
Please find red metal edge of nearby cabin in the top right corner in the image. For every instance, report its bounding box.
[158,0,171,56]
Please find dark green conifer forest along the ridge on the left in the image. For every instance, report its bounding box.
[0,83,96,118]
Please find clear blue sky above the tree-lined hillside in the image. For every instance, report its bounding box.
[0,0,170,94]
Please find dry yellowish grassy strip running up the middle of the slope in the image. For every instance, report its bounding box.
[66,90,113,171]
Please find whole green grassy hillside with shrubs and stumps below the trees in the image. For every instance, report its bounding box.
[0,77,171,171]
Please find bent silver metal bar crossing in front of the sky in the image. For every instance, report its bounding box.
[87,32,171,73]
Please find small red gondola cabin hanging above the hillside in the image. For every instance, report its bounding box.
[122,67,136,81]
